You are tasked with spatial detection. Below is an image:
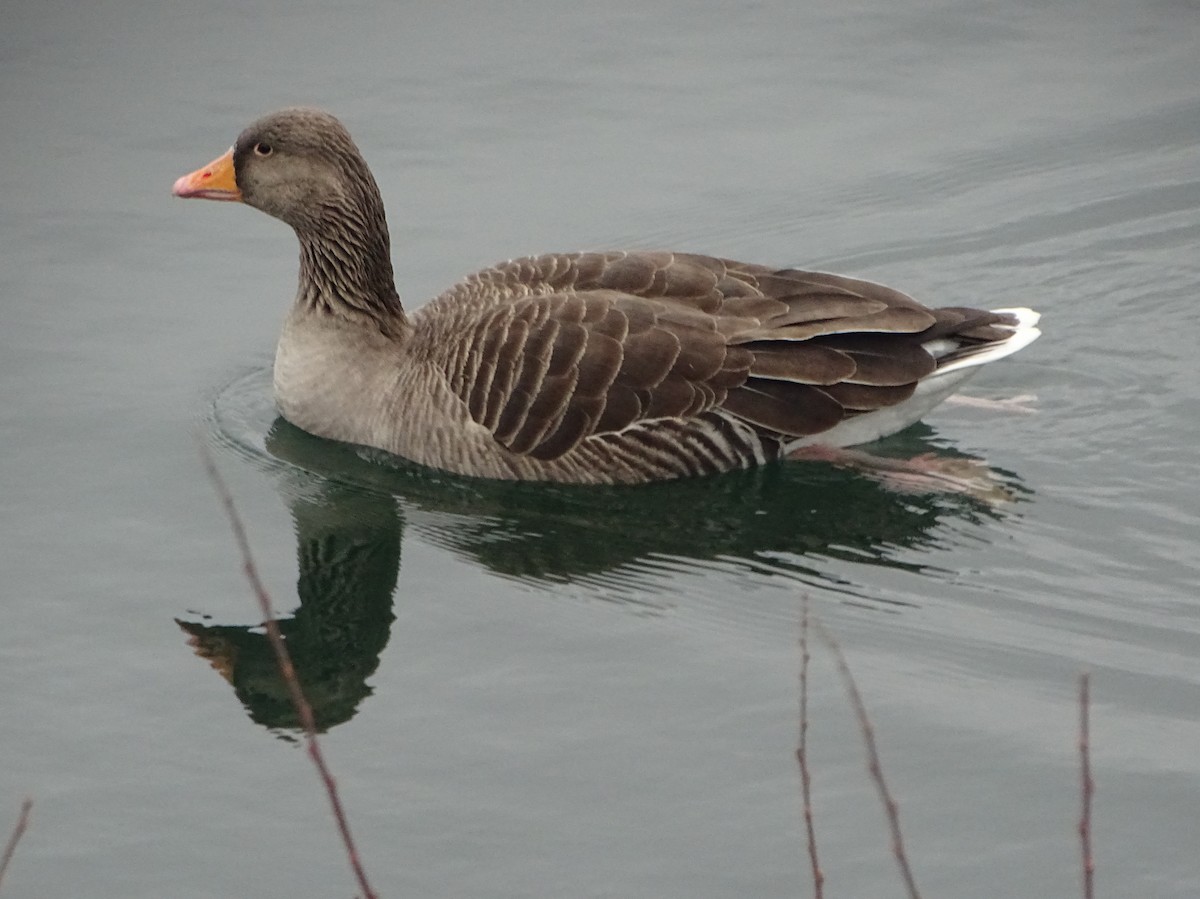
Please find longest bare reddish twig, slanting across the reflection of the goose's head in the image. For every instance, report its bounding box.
[200,443,376,899]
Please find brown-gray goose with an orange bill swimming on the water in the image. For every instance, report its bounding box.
[173,108,1040,484]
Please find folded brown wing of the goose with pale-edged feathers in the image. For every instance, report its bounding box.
[430,252,1008,460]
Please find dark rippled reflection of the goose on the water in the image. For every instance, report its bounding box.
[179,410,1022,732]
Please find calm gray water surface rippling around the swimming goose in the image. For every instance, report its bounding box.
[0,0,1200,899]
